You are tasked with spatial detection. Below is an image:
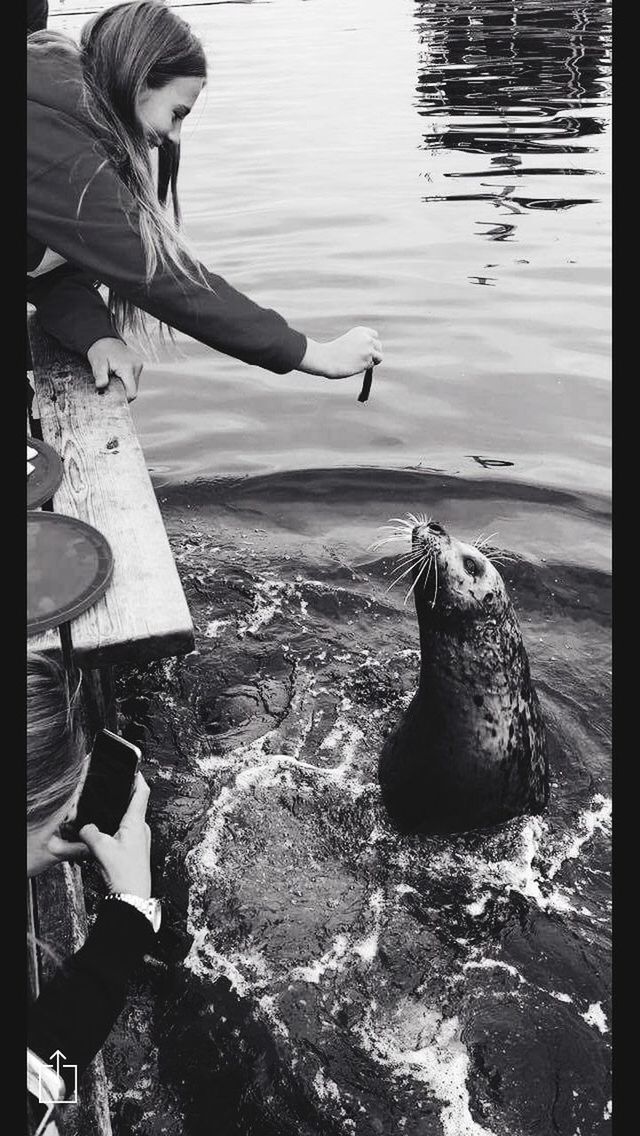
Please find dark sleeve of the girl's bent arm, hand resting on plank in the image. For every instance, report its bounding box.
[27,265,120,356]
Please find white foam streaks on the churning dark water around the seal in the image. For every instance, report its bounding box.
[176,595,610,1136]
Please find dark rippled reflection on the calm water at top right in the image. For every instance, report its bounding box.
[415,0,610,230]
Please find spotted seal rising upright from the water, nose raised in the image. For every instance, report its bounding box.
[379,518,549,833]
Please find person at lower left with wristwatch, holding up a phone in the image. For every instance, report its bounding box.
[27,654,160,1124]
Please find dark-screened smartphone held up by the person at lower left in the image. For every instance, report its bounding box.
[73,729,142,836]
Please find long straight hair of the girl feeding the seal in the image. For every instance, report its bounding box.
[80,0,207,336]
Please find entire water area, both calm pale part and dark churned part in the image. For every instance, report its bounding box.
[51,0,610,1136]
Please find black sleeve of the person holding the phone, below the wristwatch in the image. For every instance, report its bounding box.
[27,900,155,1089]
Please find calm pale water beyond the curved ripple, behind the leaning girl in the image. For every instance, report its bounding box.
[50,0,609,492]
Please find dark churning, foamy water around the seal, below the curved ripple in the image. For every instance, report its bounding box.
[92,470,610,1136]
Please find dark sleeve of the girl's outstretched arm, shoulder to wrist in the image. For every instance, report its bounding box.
[27,100,307,374]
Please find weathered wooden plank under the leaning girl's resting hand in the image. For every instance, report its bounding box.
[28,315,193,667]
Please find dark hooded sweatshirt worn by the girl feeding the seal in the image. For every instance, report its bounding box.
[27,31,307,374]
